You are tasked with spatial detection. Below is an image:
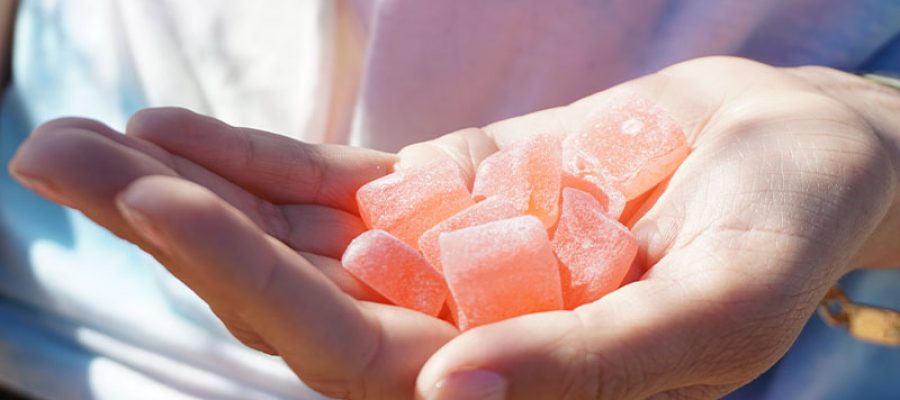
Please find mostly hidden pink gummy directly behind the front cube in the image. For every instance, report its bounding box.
[419,196,522,271]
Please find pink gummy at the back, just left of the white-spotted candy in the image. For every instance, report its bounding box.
[472,135,562,227]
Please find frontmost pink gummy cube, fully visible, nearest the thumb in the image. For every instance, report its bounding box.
[439,215,563,330]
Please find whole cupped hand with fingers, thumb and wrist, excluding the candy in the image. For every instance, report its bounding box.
[10,58,900,399]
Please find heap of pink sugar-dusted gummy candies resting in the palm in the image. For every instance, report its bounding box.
[342,95,690,330]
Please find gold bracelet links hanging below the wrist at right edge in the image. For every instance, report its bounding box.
[818,286,900,346]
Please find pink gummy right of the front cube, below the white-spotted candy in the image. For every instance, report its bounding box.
[553,188,638,309]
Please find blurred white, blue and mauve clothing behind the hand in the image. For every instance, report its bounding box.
[0,0,900,399]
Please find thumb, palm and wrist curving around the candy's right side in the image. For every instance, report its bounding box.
[400,58,900,399]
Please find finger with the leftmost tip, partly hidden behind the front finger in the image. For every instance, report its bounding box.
[10,118,285,244]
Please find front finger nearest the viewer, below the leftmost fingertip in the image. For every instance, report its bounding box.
[118,177,379,388]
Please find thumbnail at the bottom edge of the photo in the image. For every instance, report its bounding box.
[428,369,507,400]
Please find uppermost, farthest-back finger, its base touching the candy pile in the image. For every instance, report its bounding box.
[127,108,395,212]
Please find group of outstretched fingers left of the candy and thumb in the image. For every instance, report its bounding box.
[10,109,458,399]
